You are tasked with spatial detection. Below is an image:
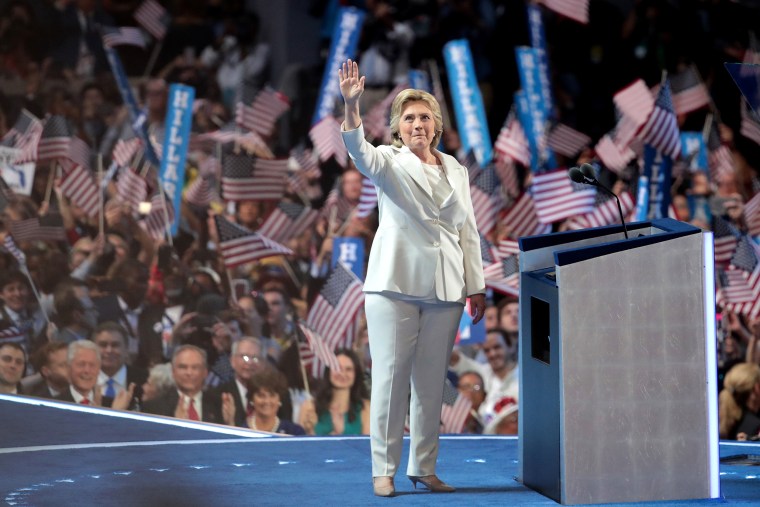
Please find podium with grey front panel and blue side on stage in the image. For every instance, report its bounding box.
[518,218,720,505]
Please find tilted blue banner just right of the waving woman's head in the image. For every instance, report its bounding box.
[443,39,493,167]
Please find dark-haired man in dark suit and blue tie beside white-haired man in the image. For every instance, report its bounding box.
[92,322,148,410]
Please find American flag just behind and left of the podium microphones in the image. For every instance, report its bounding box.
[532,169,596,224]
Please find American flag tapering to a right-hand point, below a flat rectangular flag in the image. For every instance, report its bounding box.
[214,215,293,269]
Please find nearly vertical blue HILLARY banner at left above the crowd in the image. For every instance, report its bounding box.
[160,84,195,236]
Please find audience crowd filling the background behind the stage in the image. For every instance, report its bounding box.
[0,0,760,439]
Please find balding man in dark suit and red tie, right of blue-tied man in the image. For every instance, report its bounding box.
[143,345,235,426]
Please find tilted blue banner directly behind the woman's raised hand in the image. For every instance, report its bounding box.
[311,7,365,125]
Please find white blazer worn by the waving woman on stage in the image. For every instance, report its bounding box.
[342,125,485,301]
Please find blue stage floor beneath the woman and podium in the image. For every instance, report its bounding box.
[0,396,760,507]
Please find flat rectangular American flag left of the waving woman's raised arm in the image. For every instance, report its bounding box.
[222,153,288,201]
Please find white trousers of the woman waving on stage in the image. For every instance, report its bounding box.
[365,293,463,477]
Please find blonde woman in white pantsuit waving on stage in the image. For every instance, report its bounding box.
[338,60,485,496]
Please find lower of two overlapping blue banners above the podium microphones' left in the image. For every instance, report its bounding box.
[515,46,557,172]
